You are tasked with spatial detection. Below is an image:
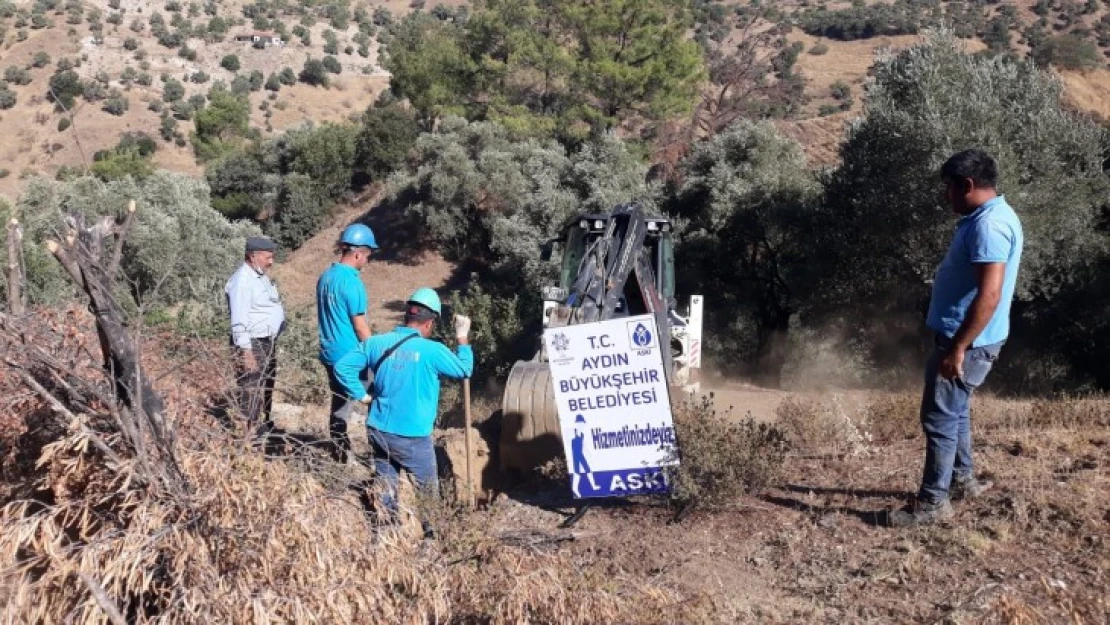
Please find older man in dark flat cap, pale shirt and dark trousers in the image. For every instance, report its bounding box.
[224,236,285,435]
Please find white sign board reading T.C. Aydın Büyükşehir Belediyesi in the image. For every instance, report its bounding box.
[544,314,678,498]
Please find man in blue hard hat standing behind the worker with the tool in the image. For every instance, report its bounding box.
[316,223,377,463]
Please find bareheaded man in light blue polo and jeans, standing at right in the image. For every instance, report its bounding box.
[890,150,1023,526]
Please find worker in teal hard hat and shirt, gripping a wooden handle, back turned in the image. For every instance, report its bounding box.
[335,288,474,537]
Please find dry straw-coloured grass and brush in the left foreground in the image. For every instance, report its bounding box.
[0,426,697,623]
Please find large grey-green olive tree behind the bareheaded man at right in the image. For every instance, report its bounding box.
[807,32,1110,387]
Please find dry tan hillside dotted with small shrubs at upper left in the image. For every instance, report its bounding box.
[0,0,461,198]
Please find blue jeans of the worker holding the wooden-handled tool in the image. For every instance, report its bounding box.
[366,427,440,530]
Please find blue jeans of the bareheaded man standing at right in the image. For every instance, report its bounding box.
[917,335,1002,504]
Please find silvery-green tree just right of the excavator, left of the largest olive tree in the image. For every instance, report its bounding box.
[668,120,820,386]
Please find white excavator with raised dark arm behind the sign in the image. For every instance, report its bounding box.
[498,203,703,471]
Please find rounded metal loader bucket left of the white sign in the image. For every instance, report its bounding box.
[501,361,563,471]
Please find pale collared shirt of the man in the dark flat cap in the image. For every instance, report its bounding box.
[223,262,285,350]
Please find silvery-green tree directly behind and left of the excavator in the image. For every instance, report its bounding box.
[389,117,652,377]
